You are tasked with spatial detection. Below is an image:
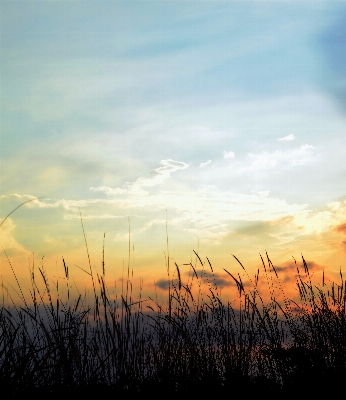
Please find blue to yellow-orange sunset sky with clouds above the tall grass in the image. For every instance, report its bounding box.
[0,0,346,300]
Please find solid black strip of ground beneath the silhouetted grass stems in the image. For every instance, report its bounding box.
[1,371,346,400]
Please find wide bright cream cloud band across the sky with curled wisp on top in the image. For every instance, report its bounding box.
[2,167,346,248]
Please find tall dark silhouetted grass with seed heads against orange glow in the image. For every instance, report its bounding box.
[0,208,346,398]
